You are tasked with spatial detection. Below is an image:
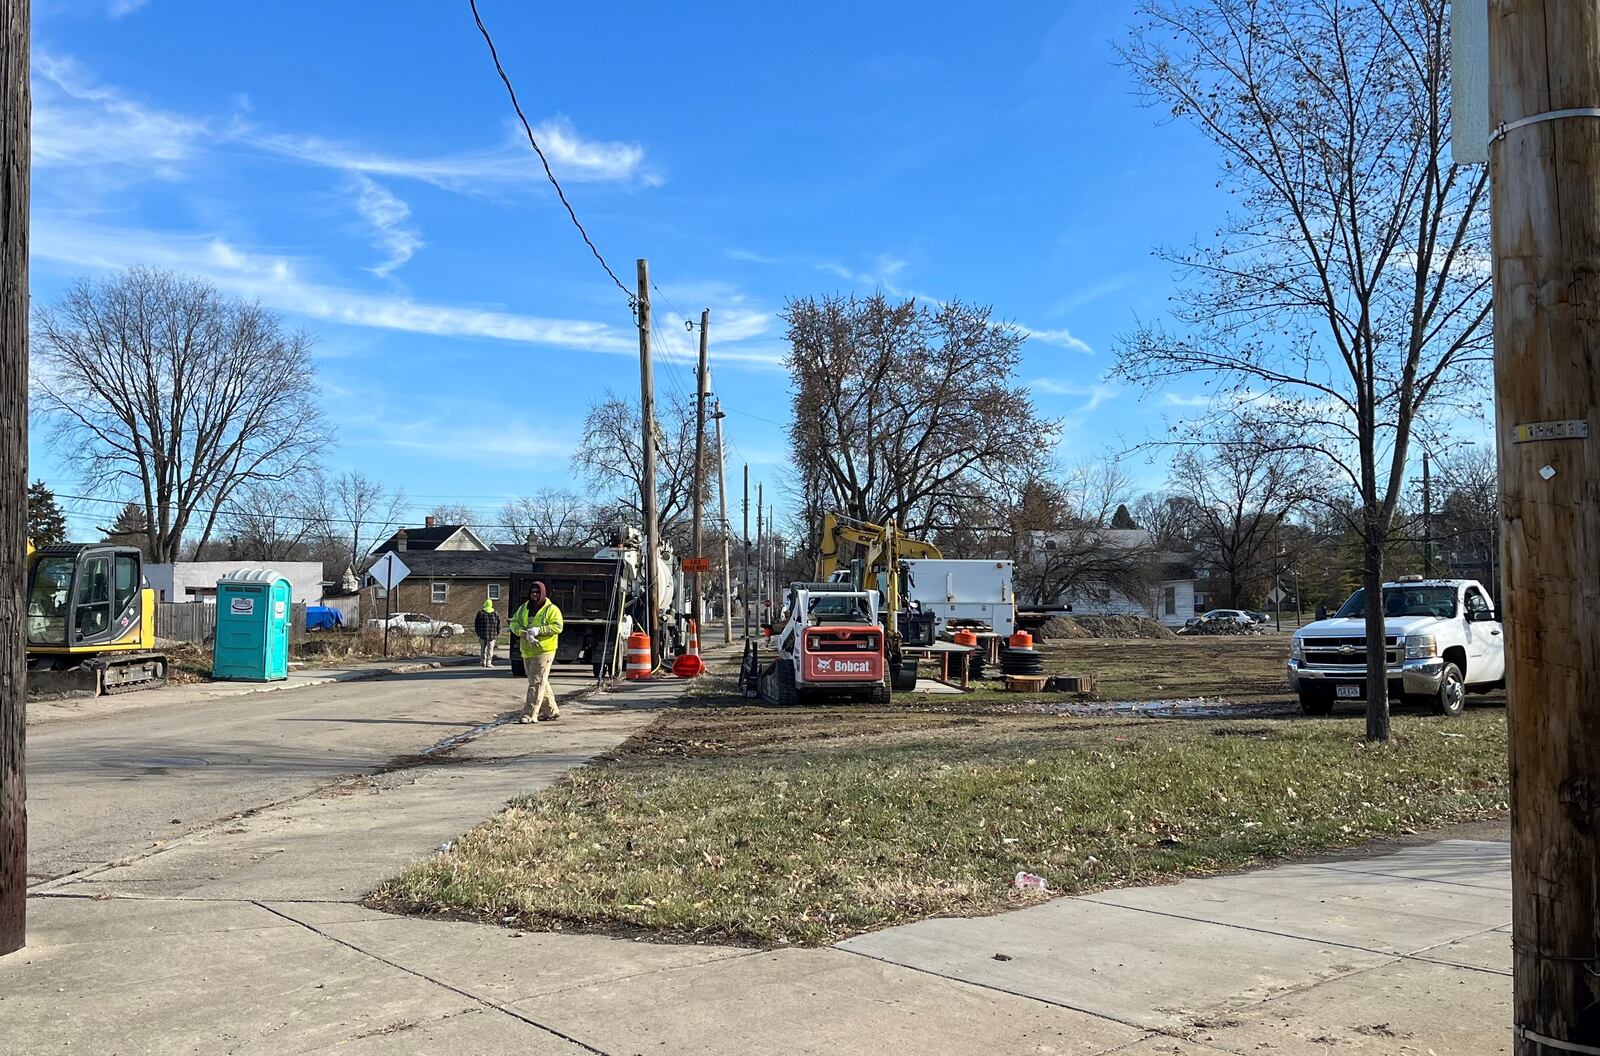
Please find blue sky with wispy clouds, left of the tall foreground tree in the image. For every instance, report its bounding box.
[32,0,1222,540]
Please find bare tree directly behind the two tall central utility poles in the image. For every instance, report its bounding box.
[573,392,717,550]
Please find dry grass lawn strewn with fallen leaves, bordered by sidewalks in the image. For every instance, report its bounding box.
[374,640,1507,944]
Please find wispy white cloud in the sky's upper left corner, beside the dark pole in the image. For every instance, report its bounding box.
[32,51,210,179]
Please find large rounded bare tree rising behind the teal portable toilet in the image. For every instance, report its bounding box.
[32,267,328,562]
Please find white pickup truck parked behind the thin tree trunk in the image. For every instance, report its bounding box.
[1288,576,1506,715]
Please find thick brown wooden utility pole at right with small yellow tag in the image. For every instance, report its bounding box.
[1490,0,1600,1056]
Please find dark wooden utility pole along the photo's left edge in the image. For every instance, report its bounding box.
[0,0,30,954]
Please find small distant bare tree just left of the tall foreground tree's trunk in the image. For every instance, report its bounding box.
[1171,443,1309,608]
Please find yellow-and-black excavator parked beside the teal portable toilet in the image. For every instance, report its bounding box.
[26,542,166,696]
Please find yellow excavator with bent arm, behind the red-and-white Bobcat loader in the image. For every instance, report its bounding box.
[816,514,944,691]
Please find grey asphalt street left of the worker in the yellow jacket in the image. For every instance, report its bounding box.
[27,666,563,882]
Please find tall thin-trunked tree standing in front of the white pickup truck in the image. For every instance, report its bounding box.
[1117,0,1490,739]
